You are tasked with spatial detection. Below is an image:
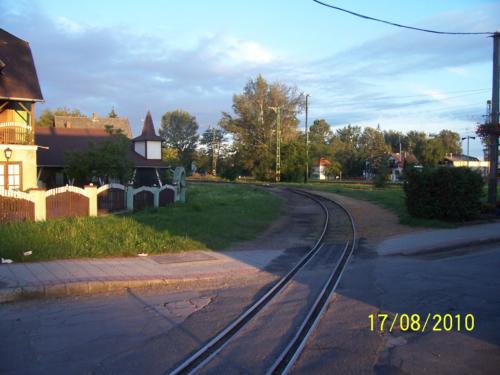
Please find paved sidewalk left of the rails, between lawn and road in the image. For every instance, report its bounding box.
[0,250,283,303]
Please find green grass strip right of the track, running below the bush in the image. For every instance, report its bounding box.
[286,183,457,228]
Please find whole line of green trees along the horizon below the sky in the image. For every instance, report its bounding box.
[38,75,462,181]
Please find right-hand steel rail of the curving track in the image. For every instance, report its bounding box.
[266,192,356,375]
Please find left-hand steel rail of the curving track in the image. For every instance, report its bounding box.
[166,189,330,375]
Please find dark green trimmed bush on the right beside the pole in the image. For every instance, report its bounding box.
[404,167,483,221]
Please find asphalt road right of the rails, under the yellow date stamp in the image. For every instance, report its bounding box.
[292,243,500,375]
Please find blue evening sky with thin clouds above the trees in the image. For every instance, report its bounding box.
[0,0,500,156]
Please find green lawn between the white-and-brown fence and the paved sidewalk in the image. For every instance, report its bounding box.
[0,184,282,261]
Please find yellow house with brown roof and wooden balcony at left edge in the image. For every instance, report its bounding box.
[0,28,43,191]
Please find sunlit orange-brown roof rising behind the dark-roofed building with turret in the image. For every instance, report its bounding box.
[54,112,132,138]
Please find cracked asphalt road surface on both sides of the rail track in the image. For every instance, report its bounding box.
[0,188,500,374]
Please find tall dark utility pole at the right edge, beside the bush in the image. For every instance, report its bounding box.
[488,32,500,205]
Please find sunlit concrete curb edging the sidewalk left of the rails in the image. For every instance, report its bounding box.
[0,272,257,304]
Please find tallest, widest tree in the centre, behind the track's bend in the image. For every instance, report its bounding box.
[219,75,304,179]
